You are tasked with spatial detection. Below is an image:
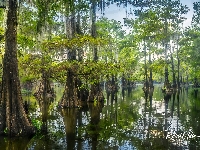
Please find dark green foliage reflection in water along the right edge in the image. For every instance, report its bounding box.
[169,88,200,149]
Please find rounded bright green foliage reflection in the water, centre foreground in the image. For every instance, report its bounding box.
[79,98,138,145]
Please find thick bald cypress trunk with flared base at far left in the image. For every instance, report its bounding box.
[0,0,34,136]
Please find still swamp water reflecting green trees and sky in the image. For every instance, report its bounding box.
[0,85,200,150]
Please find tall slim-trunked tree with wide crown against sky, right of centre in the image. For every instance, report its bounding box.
[132,0,188,91]
